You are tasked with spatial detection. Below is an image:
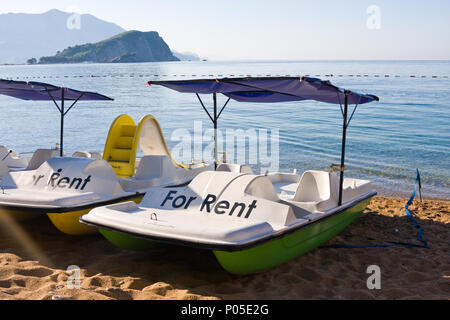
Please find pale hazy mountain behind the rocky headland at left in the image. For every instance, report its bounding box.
[0,10,125,63]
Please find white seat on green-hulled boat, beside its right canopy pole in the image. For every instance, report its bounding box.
[293,171,339,211]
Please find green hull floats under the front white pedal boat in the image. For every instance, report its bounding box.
[100,199,370,275]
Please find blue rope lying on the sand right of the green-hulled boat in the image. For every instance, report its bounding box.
[321,169,430,249]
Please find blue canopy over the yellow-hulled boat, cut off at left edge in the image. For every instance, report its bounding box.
[0,79,113,101]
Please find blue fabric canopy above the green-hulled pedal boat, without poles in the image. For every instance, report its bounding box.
[149,77,379,105]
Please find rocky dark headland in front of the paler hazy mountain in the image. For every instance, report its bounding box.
[39,31,179,64]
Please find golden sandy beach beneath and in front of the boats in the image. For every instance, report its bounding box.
[0,197,450,300]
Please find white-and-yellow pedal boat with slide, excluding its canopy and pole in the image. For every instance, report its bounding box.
[0,115,211,235]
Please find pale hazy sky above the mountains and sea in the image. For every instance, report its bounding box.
[0,0,450,60]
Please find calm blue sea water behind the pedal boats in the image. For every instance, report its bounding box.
[0,61,450,199]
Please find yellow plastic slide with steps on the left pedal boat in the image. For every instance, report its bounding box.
[103,115,188,178]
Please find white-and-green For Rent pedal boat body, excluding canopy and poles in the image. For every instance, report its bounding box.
[80,165,376,274]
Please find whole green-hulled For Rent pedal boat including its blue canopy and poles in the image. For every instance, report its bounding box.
[80,77,379,274]
